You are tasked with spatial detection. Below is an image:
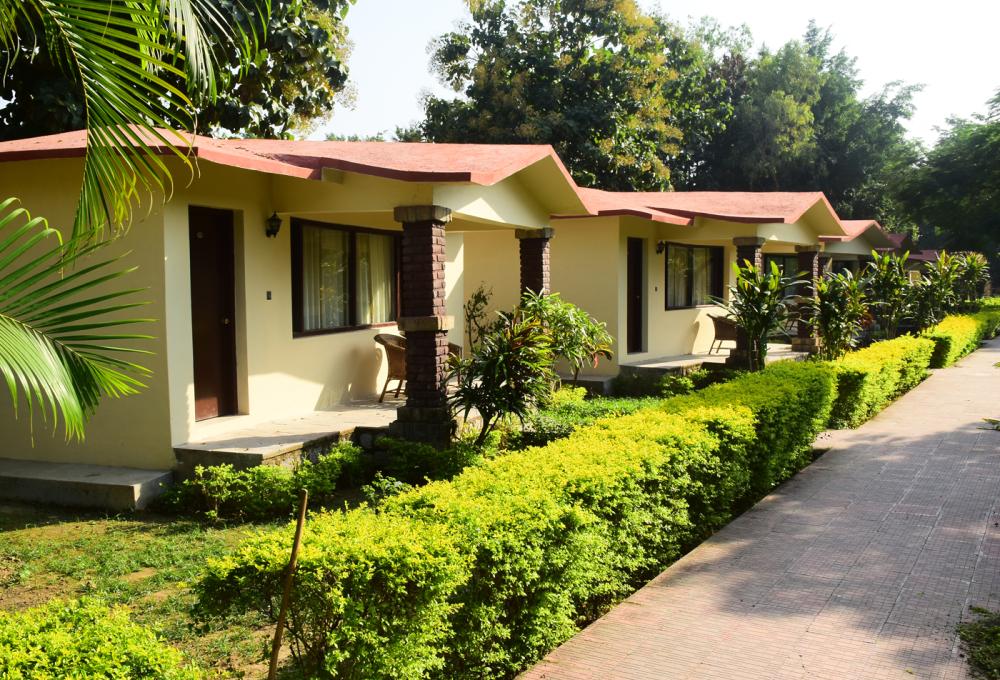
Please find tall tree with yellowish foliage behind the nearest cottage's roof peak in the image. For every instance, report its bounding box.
[400,0,681,190]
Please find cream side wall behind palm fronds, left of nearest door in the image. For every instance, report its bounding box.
[0,159,174,469]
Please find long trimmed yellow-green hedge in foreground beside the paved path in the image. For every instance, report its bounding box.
[197,363,835,678]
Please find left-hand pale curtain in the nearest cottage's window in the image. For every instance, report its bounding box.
[302,226,350,331]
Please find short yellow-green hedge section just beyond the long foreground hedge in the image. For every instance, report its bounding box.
[830,335,934,428]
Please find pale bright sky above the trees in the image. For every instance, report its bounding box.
[311,0,1000,144]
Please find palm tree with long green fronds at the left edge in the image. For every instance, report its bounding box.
[0,0,270,437]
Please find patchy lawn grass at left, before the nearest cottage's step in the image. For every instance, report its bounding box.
[0,504,285,678]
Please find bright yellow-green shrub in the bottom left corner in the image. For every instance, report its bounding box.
[0,599,205,680]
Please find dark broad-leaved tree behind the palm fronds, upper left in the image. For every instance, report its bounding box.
[0,0,354,140]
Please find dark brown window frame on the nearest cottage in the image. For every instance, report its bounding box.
[290,217,402,338]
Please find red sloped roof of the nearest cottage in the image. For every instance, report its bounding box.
[0,130,576,189]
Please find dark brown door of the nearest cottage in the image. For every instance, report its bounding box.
[189,207,237,420]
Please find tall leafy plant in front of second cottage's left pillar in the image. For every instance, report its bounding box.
[713,260,797,371]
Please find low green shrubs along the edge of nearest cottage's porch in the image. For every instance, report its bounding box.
[160,443,365,521]
